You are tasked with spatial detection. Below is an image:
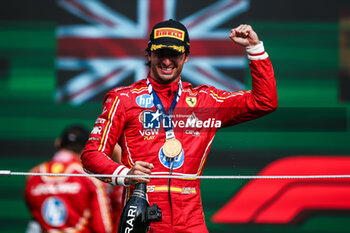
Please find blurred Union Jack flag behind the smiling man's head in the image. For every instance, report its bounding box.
[56,0,249,104]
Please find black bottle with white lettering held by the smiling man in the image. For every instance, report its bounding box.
[118,183,162,233]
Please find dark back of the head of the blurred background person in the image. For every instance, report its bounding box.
[59,125,90,154]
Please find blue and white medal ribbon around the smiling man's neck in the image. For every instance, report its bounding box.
[147,78,182,140]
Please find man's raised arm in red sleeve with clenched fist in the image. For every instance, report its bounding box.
[218,24,278,126]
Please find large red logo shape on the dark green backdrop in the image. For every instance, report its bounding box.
[212,156,350,224]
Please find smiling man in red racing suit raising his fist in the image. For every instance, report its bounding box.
[82,21,277,233]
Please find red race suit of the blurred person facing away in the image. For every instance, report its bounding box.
[25,150,112,233]
